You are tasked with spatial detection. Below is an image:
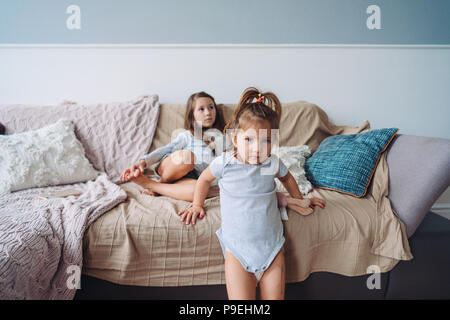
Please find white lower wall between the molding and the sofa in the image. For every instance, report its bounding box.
[0,44,450,139]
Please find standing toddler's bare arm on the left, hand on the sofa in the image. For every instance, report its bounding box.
[178,167,215,225]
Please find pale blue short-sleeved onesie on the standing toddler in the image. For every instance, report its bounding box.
[210,152,288,274]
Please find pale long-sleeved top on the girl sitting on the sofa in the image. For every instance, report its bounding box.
[141,129,232,178]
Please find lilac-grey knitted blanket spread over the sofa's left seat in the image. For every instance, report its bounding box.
[0,174,127,299]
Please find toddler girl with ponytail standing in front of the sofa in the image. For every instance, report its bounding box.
[179,88,325,299]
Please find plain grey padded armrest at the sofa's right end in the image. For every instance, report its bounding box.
[386,134,450,238]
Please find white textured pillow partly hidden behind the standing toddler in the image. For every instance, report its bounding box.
[273,145,313,195]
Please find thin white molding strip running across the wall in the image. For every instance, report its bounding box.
[0,43,450,49]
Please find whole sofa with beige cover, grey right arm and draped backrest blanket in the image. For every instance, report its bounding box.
[4,96,450,299]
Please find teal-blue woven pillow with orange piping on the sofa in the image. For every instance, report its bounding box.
[305,128,399,198]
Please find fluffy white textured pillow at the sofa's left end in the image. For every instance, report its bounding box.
[0,119,100,195]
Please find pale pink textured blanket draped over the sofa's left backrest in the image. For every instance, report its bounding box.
[0,95,159,182]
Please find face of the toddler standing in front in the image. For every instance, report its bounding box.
[233,120,272,164]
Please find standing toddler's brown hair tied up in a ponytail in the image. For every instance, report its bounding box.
[223,87,281,134]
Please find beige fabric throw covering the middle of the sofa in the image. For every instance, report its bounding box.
[83,101,412,287]
